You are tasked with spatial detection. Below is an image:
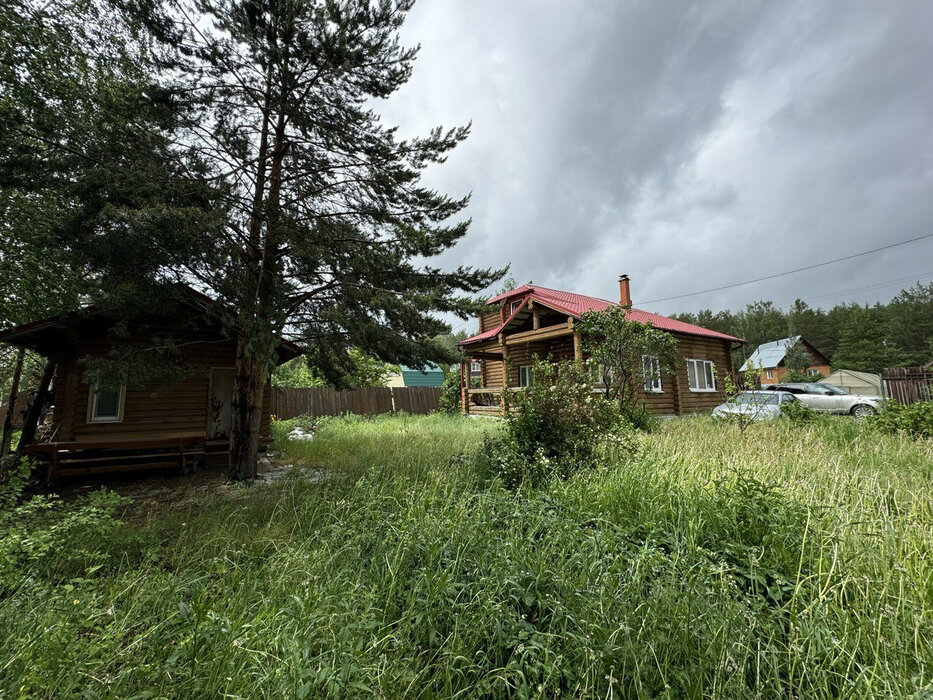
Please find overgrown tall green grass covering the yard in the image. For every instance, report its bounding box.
[0,416,933,698]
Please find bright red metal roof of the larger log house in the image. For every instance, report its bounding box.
[458,284,745,345]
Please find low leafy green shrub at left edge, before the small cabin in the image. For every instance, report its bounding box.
[0,459,128,591]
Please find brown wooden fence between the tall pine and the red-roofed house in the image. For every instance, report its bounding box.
[272,386,441,420]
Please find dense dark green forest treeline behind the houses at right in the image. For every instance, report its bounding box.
[672,282,933,373]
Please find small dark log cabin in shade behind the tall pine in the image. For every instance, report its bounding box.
[0,289,300,481]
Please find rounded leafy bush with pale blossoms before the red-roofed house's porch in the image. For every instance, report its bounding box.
[478,362,631,488]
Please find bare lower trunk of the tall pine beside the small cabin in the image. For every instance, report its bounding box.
[230,334,266,480]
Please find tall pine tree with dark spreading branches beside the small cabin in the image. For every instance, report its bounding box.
[160,0,500,478]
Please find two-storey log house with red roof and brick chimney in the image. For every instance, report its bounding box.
[458,275,745,416]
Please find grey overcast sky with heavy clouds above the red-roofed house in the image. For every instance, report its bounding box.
[381,0,933,326]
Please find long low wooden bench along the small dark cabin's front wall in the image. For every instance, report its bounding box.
[26,435,206,483]
